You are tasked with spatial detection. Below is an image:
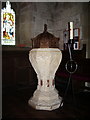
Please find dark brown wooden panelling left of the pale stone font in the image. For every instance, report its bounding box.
[2,50,37,87]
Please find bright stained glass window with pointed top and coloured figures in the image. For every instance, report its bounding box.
[1,1,15,45]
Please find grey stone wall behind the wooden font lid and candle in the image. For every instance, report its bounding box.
[19,2,88,49]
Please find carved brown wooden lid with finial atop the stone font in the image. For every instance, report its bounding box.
[31,24,59,48]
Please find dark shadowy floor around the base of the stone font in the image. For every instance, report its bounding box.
[2,87,90,120]
